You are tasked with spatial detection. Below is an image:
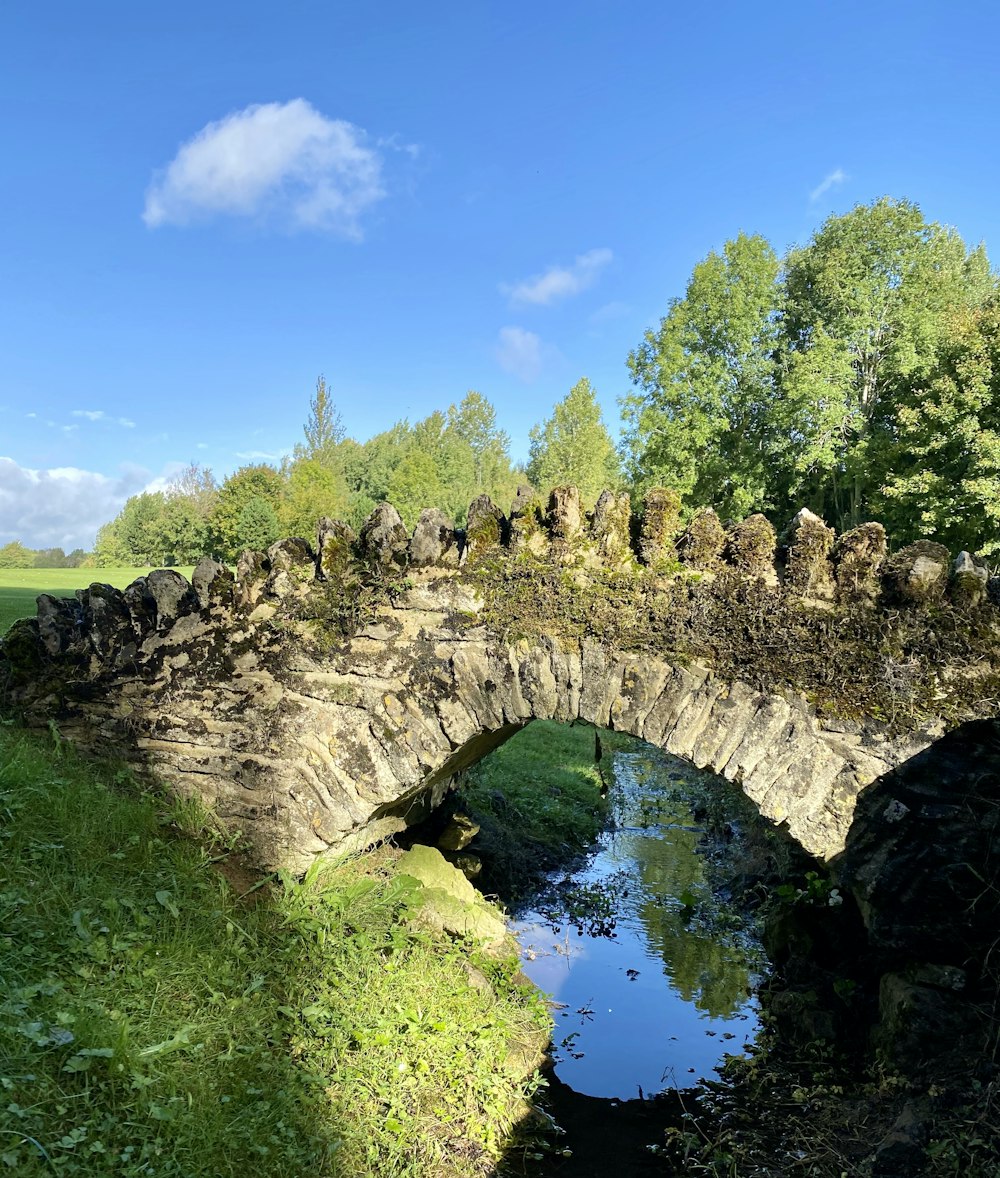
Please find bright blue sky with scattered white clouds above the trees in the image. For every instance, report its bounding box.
[0,0,1000,549]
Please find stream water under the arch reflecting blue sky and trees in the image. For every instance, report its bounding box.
[516,746,762,1098]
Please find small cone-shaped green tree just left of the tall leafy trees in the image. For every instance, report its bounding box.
[528,377,621,507]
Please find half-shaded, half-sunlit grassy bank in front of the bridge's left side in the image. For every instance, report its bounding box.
[0,726,548,1178]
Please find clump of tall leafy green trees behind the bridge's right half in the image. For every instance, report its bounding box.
[623,198,1000,550]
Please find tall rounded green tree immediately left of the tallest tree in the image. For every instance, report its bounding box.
[623,233,781,516]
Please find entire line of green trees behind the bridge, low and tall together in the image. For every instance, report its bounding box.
[13,198,1000,565]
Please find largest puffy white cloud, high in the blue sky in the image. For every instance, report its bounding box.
[143,98,385,240]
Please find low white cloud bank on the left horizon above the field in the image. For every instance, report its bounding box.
[0,457,157,552]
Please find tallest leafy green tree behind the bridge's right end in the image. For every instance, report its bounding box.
[782,198,995,527]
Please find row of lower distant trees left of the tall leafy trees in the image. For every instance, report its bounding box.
[91,377,621,565]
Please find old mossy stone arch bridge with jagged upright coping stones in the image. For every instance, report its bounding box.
[0,488,1000,871]
